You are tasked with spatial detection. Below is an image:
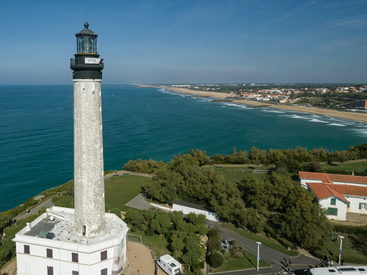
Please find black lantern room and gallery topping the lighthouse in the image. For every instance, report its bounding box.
[70,22,104,79]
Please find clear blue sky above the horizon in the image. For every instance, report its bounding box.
[0,0,367,85]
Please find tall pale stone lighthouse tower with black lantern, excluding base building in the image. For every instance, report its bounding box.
[70,22,105,237]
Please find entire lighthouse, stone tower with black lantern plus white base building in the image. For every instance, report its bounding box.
[13,22,129,275]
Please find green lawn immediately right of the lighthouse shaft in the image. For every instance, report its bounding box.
[105,176,150,211]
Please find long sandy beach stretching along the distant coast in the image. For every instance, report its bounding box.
[139,85,367,124]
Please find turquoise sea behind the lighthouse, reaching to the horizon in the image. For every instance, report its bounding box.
[0,86,367,211]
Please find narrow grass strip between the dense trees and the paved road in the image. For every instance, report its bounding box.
[221,223,299,256]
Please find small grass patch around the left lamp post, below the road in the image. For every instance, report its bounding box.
[213,251,271,272]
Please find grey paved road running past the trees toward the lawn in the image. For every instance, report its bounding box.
[126,194,319,275]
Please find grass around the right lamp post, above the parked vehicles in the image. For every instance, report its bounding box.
[315,233,367,264]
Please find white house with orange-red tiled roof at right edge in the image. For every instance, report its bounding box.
[298,171,367,221]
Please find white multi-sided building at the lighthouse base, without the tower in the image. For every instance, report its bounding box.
[13,206,129,275]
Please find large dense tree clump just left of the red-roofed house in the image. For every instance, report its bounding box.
[239,173,331,252]
